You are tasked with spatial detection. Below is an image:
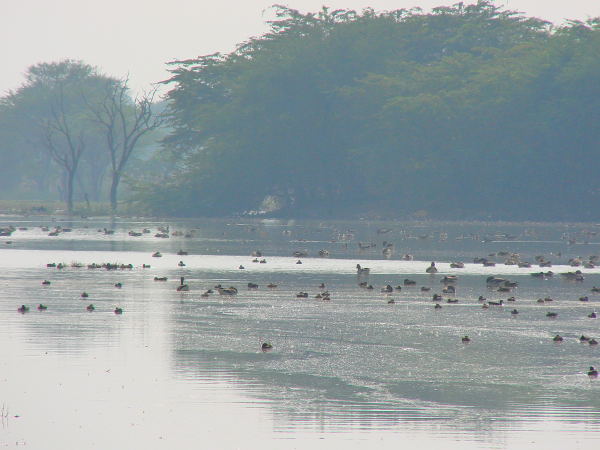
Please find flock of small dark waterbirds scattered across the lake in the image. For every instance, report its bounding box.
[0,226,600,378]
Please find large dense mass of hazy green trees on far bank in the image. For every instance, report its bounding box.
[132,1,600,220]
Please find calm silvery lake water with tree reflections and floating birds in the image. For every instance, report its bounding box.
[0,217,600,450]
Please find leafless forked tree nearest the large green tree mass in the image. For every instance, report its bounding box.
[87,78,164,211]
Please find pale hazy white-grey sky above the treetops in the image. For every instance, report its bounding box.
[0,0,600,95]
